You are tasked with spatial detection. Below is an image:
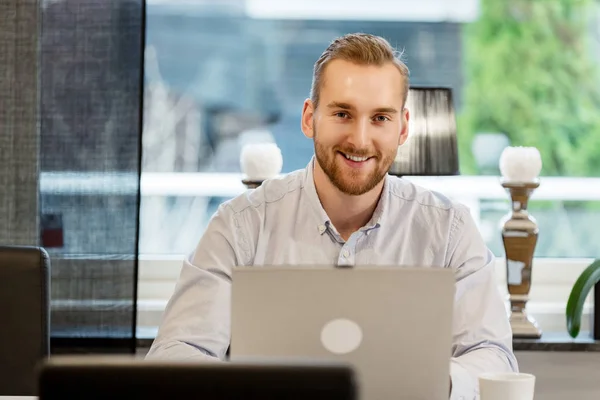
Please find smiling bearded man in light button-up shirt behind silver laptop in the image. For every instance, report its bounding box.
[148,34,517,399]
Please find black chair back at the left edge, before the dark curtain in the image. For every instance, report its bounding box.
[0,246,50,396]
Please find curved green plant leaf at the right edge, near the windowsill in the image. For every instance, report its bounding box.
[567,259,600,338]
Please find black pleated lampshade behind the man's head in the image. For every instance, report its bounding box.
[389,86,459,176]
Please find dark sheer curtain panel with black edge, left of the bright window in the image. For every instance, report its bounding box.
[39,0,143,349]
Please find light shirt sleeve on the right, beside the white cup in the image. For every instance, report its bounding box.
[447,206,518,400]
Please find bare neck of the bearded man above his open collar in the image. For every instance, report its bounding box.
[314,161,384,240]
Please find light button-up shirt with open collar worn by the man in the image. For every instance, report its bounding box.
[147,157,518,400]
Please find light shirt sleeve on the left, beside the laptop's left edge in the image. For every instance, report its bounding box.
[146,203,243,361]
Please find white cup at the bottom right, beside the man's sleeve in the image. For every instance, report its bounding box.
[479,372,535,400]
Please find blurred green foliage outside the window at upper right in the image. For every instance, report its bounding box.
[458,0,600,176]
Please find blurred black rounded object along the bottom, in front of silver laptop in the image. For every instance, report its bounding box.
[38,356,357,400]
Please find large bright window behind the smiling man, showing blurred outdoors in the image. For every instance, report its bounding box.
[135,0,600,338]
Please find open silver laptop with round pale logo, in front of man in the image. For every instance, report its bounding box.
[230,266,455,400]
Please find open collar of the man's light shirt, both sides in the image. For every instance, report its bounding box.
[303,155,390,234]
